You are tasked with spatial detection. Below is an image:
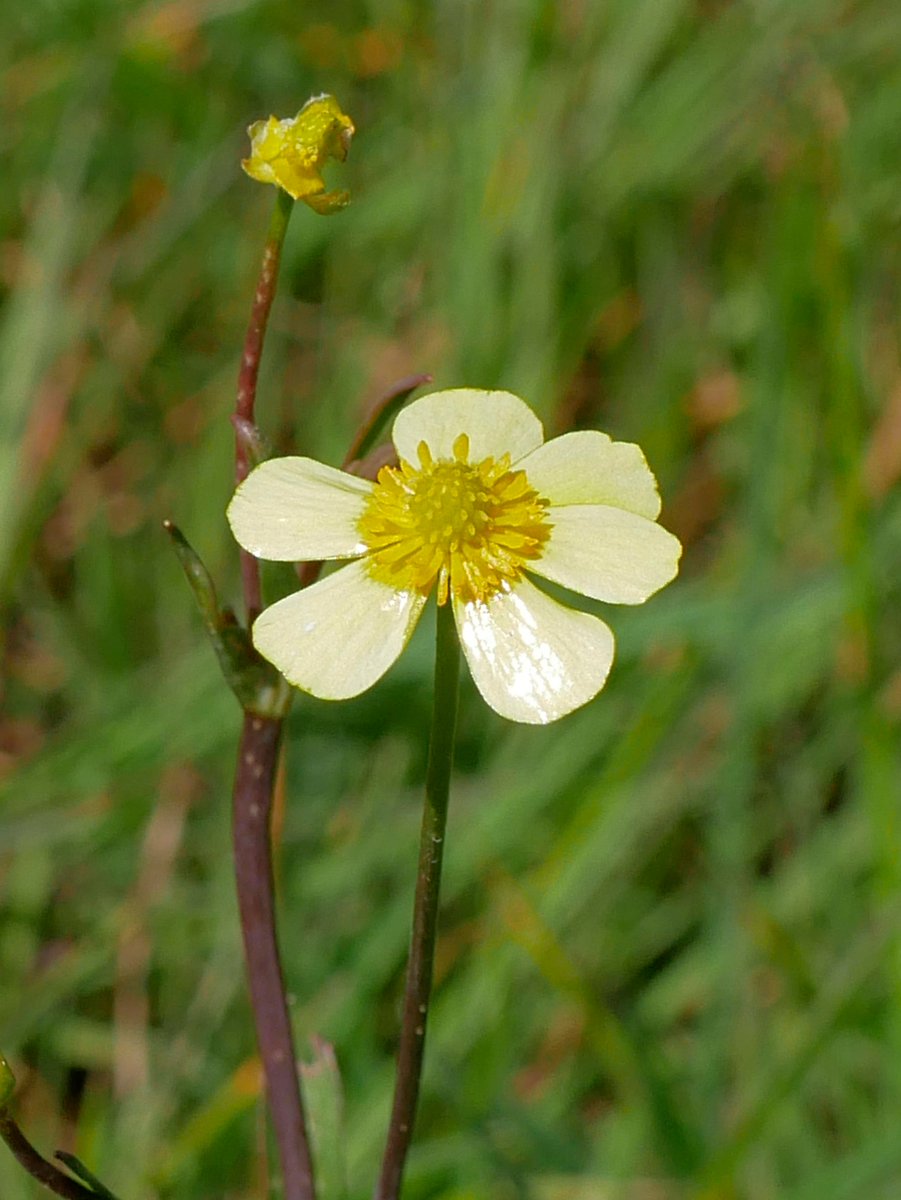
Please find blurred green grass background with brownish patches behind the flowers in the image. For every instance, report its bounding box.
[0,0,901,1200]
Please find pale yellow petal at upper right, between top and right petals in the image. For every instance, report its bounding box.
[516,430,660,521]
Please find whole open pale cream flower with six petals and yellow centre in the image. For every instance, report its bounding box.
[228,389,681,724]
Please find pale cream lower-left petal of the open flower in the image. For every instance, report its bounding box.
[253,559,426,700]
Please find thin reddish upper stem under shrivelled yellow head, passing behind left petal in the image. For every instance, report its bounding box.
[235,187,294,624]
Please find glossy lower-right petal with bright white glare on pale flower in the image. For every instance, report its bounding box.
[453,580,613,725]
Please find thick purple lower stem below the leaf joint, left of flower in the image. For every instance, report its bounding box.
[234,713,316,1200]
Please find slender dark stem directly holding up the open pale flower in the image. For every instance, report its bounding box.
[376,604,459,1200]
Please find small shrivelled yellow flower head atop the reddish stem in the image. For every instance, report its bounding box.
[241,96,354,215]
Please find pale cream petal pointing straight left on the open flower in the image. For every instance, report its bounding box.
[228,458,372,563]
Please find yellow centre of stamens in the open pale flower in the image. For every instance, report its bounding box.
[359,433,552,605]
